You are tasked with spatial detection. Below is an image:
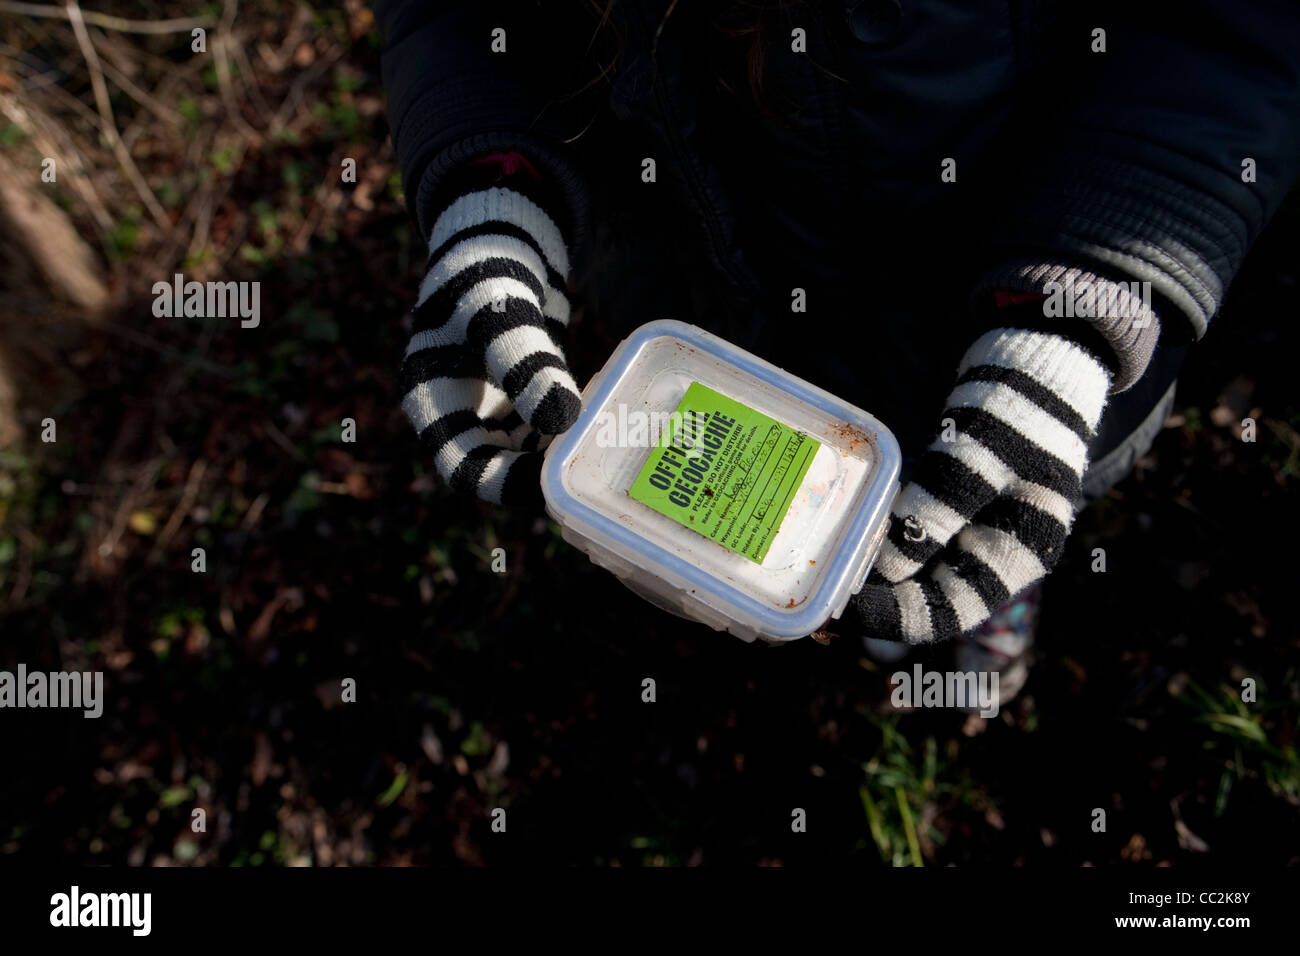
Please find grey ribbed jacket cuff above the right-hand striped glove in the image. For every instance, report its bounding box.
[971,256,1160,393]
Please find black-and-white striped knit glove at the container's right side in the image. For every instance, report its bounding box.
[852,329,1110,643]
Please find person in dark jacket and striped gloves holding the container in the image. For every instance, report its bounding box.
[377,0,1300,679]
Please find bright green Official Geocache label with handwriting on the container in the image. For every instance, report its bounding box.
[628,382,822,564]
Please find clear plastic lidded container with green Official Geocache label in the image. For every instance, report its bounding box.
[542,320,900,643]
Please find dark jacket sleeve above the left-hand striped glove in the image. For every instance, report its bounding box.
[376,0,588,243]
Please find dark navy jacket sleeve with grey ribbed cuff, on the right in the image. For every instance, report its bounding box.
[976,0,1300,392]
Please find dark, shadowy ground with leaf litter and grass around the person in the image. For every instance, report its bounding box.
[0,0,1300,866]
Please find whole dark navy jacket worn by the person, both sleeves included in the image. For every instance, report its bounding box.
[377,0,1300,421]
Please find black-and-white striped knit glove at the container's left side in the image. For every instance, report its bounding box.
[402,186,581,503]
